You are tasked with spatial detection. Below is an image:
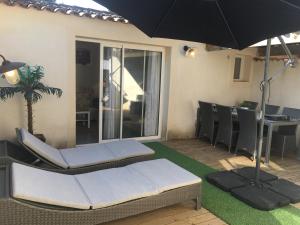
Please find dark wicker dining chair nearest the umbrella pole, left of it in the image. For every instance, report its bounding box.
[235,108,257,159]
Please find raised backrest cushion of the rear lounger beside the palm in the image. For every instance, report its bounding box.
[21,128,69,169]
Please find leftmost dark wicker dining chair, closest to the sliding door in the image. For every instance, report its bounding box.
[199,101,216,144]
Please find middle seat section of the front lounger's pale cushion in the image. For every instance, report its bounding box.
[76,167,158,209]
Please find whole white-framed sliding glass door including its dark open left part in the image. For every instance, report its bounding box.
[76,41,163,144]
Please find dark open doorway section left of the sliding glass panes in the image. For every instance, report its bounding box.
[76,41,100,145]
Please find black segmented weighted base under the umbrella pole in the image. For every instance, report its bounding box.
[206,167,300,211]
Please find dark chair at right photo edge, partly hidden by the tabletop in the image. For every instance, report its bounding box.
[271,107,300,159]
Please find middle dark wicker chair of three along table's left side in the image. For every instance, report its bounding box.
[215,105,238,152]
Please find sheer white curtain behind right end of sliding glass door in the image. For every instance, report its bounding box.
[144,51,162,136]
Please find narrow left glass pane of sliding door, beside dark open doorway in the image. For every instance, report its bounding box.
[102,47,122,140]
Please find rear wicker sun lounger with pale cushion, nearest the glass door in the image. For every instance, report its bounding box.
[16,129,154,173]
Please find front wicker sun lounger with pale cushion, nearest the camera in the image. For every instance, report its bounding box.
[0,159,201,225]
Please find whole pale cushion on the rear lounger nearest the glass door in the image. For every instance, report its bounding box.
[21,128,154,169]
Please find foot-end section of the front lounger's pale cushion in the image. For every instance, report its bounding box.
[127,159,201,192]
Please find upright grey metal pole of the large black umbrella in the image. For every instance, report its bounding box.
[255,39,271,184]
